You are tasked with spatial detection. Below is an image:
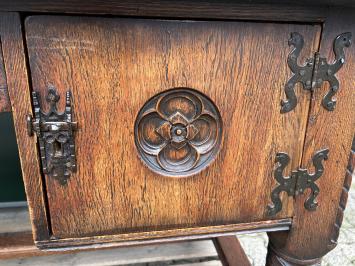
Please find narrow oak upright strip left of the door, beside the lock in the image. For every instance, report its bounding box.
[0,13,49,240]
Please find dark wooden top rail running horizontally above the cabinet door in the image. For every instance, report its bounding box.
[0,0,334,22]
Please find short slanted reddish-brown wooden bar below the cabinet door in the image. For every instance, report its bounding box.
[212,236,251,266]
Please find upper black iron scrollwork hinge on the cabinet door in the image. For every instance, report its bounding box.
[281,32,352,113]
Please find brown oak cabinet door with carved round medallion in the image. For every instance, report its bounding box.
[25,16,320,245]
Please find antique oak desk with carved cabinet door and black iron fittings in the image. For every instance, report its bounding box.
[0,0,355,265]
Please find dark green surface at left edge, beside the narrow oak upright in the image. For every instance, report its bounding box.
[0,113,26,202]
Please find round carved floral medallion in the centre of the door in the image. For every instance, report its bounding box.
[134,88,222,177]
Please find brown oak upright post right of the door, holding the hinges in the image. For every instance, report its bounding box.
[269,10,355,260]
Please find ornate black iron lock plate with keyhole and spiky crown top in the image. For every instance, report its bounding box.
[27,86,77,185]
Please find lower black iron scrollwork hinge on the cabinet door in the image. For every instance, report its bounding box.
[267,149,329,216]
